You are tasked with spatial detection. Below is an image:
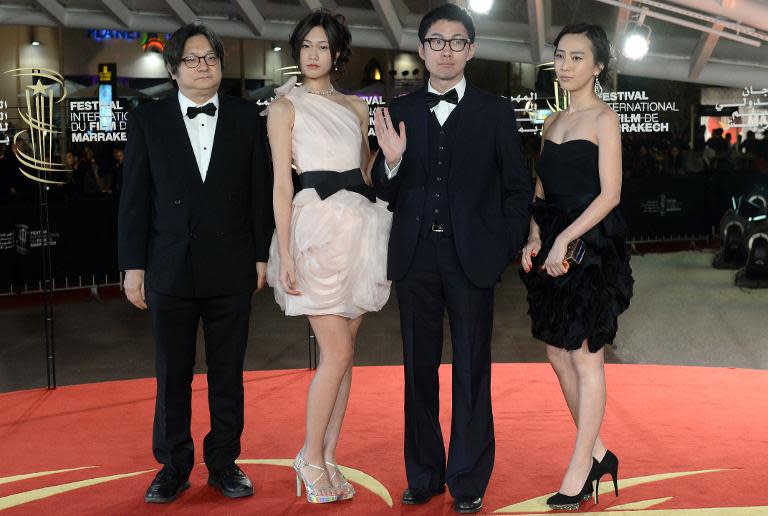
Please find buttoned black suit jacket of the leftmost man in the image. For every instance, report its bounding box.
[118,95,274,297]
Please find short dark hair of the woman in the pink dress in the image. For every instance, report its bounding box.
[288,8,352,72]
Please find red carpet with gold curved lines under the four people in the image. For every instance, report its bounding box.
[0,364,768,516]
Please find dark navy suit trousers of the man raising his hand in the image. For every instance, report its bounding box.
[396,232,495,497]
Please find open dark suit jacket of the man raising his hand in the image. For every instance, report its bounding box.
[374,84,532,288]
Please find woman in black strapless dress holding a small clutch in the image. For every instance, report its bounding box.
[520,24,633,510]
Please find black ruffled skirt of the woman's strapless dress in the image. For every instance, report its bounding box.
[520,199,634,353]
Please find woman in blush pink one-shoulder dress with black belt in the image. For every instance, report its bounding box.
[267,9,392,503]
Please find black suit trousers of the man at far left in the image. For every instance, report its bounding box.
[147,291,253,477]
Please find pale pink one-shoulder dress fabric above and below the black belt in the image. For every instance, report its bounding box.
[267,79,392,318]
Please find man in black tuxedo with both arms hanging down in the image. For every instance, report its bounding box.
[118,24,274,503]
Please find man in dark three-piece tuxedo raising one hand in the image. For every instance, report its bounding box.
[374,4,532,513]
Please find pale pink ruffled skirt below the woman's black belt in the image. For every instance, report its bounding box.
[267,188,392,318]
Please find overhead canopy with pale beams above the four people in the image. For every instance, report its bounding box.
[0,0,768,87]
